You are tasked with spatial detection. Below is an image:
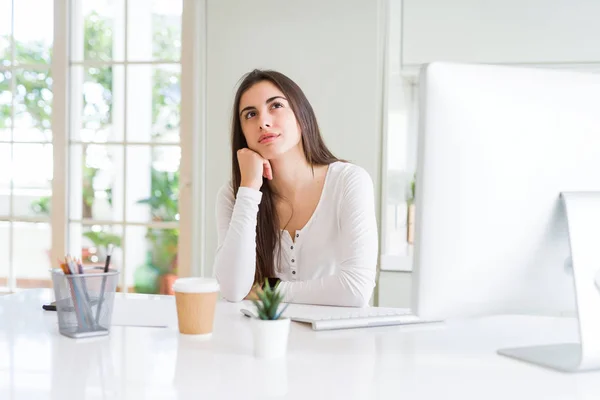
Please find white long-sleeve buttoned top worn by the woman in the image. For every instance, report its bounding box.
[213,162,378,307]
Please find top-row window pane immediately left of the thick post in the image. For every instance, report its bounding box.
[14,0,54,65]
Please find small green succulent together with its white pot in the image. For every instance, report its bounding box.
[251,280,290,358]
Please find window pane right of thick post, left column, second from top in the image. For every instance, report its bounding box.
[71,65,125,142]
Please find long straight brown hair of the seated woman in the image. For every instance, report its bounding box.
[231,69,338,284]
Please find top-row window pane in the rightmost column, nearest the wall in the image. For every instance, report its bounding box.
[127,0,182,61]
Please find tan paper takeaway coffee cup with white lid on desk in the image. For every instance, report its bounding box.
[173,278,219,337]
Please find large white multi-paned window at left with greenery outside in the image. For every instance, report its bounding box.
[0,0,199,293]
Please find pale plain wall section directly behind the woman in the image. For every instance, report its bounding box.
[204,0,383,275]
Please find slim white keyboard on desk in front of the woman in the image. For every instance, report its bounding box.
[242,304,440,331]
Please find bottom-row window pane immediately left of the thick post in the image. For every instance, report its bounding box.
[13,222,51,288]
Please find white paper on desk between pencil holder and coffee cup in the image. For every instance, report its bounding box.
[111,294,177,328]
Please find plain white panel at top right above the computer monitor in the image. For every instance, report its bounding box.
[402,0,600,65]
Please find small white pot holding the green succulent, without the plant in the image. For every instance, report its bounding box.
[251,318,290,358]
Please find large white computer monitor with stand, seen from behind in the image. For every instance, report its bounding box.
[413,62,600,370]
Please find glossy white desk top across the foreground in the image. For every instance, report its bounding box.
[0,290,600,400]
